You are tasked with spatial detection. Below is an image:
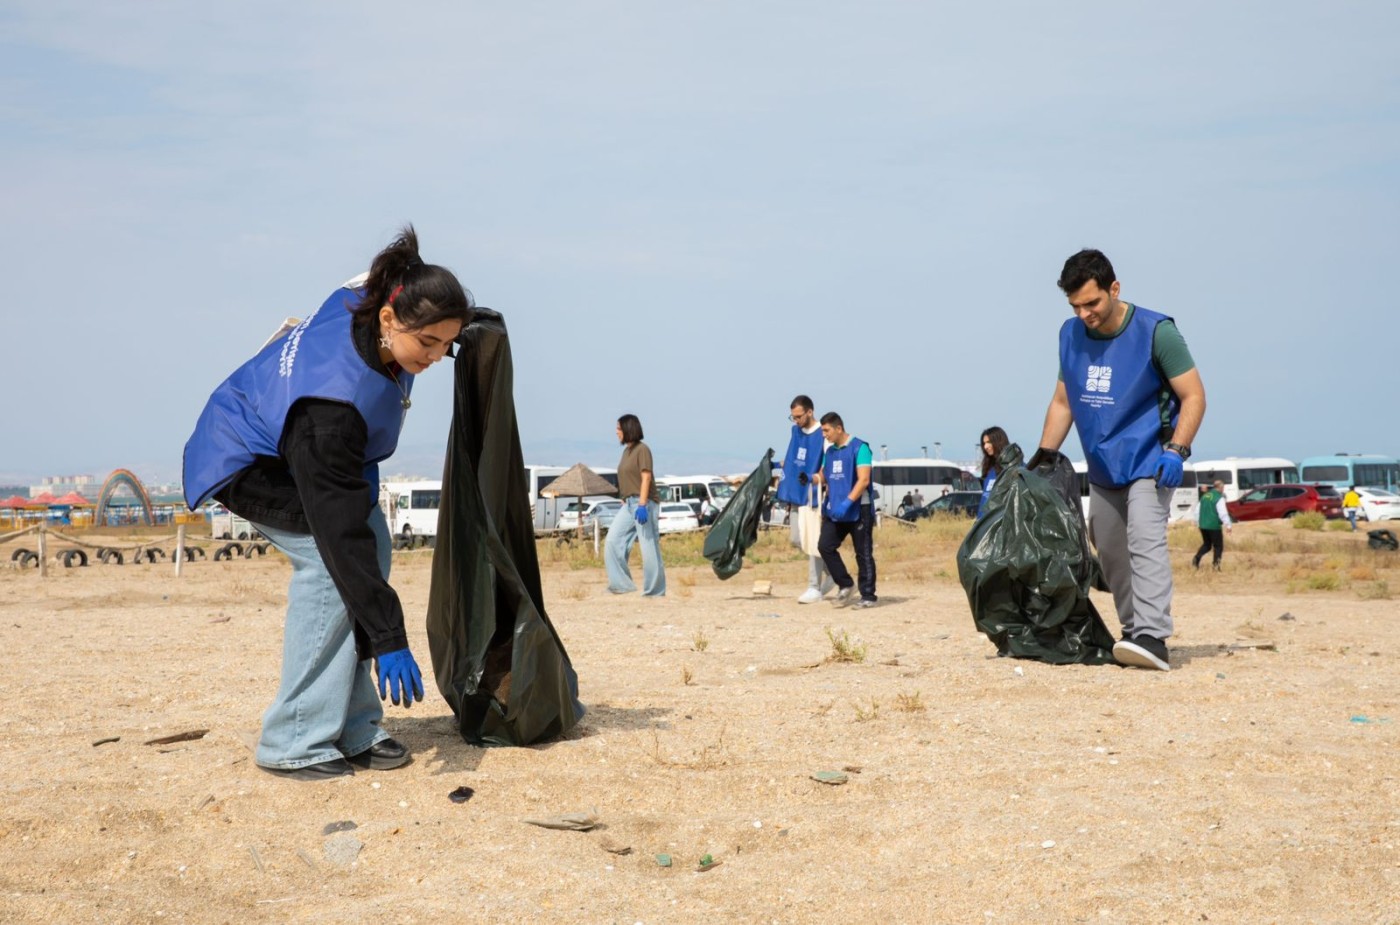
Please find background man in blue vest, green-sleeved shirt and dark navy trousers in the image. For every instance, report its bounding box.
[815,411,878,607]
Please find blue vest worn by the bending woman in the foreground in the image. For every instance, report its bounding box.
[185,288,413,509]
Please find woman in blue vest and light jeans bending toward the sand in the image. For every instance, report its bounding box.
[185,227,473,781]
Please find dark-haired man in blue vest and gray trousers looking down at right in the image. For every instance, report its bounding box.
[1029,250,1205,672]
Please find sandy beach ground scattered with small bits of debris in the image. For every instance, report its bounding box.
[0,525,1400,925]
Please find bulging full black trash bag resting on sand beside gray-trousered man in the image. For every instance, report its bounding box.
[958,444,1113,665]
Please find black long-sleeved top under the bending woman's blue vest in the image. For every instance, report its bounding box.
[214,317,409,658]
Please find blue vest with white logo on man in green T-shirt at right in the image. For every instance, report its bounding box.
[1060,306,1180,488]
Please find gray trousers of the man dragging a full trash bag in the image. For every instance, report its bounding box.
[1089,479,1173,640]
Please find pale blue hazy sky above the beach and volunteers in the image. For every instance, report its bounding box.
[0,0,1400,481]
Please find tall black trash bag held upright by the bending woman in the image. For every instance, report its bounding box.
[427,309,584,746]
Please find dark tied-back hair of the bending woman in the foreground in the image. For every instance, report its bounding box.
[351,225,476,330]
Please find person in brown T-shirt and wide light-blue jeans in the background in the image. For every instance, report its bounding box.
[603,414,666,598]
